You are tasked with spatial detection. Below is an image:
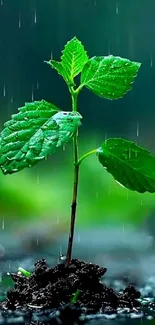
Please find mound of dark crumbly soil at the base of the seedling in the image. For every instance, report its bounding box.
[1,259,141,314]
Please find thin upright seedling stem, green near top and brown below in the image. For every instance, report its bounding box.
[66,88,79,265]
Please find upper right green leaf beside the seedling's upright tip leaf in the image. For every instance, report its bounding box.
[81,55,141,99]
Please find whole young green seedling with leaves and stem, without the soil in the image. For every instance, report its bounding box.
[0,37,155,264]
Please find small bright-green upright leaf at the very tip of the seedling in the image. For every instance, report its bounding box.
[47,37,89,85]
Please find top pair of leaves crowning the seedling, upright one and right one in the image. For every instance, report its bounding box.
[47,37,141,99]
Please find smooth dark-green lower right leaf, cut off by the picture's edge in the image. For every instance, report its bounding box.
[97,138,155,193]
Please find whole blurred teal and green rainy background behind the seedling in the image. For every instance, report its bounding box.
[0,0,155,278]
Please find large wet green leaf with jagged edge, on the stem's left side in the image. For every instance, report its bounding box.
[0,101,81,174]
